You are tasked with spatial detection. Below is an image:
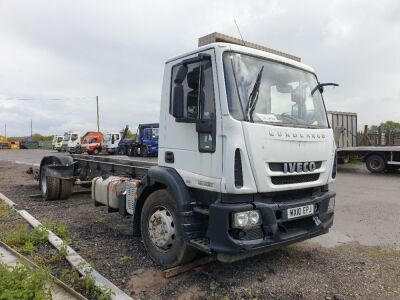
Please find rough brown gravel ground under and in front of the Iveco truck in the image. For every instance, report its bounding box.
[0,161,400,299]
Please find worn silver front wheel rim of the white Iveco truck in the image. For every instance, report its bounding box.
[148,207,175,250]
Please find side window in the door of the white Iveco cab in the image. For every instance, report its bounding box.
[170,59,215,122]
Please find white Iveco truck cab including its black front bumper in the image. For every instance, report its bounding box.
[158,34,336,260]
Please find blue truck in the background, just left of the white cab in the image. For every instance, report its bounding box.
[126,123,159,157]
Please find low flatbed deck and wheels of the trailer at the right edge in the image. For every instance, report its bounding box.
[337,146,400,173]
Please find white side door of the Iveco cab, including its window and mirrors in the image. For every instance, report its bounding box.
[159,50,222,191]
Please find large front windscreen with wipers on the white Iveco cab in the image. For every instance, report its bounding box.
[224,52,328,128]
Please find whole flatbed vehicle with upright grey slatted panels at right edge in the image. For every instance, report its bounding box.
[328,111,400,173]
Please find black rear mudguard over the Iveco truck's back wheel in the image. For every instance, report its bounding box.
[39,155,75,179]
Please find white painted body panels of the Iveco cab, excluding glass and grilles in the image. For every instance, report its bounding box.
[158,43,335,194]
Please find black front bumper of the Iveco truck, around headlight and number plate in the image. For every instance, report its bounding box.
[207,191,336,254]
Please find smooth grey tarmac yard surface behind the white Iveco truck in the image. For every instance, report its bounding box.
[0,150,400,249]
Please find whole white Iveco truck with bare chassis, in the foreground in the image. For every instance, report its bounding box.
[39,33,336,267]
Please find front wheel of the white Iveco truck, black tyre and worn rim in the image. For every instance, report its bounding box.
[140,190,197,268]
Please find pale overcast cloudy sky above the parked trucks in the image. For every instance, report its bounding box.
[0,0,400,136]
